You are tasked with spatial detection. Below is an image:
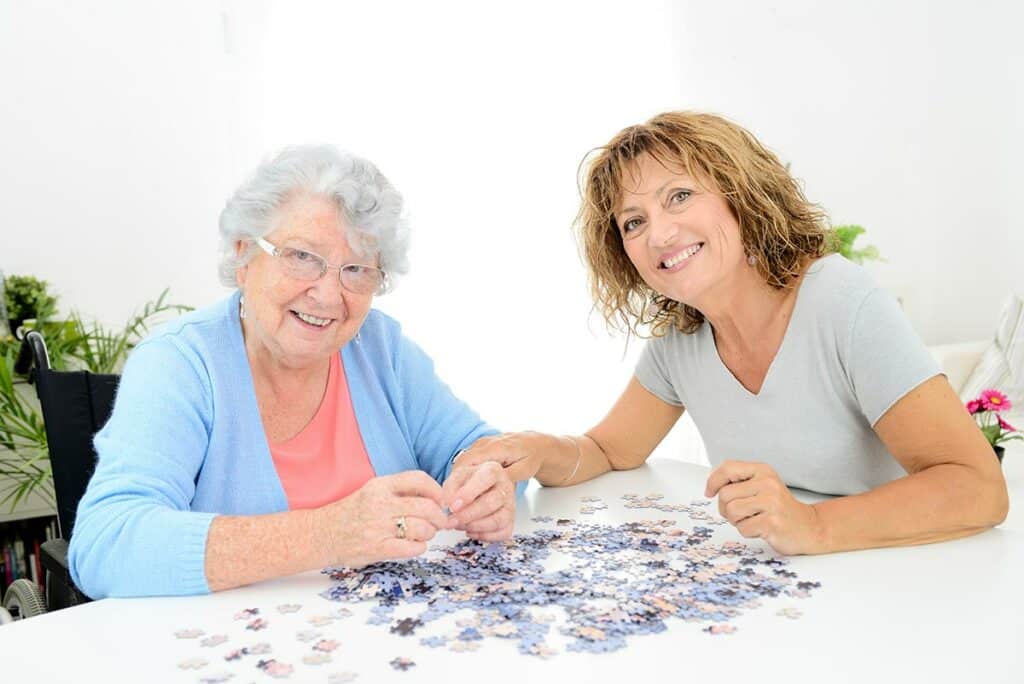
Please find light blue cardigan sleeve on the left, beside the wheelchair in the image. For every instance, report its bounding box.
[69,337,214,598]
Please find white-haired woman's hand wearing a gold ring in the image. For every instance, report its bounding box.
[317,470,447,567]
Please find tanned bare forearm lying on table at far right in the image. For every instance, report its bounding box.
[813,463,1009,553]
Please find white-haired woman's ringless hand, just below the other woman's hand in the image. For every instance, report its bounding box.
[443,461,515,542]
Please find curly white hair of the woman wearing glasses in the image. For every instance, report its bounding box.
[218,145,409,287]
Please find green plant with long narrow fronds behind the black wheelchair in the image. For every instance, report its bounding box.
[0,290,191,510]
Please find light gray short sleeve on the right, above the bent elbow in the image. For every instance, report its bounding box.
[846,289,940,427]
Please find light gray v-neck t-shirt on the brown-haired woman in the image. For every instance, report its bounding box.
[636,254,939,495]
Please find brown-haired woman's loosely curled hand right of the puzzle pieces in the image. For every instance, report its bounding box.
[705,461,822,555]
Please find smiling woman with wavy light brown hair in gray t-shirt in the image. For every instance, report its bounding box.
[463,112,1008,554]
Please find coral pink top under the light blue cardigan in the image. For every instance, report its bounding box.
[268,354,375,510]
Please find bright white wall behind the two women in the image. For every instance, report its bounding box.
[0,0,1024,464]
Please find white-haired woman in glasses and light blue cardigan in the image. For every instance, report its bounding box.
[69,146,515,598]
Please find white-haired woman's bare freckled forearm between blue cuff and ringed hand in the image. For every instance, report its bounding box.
[206,509,332,591]
